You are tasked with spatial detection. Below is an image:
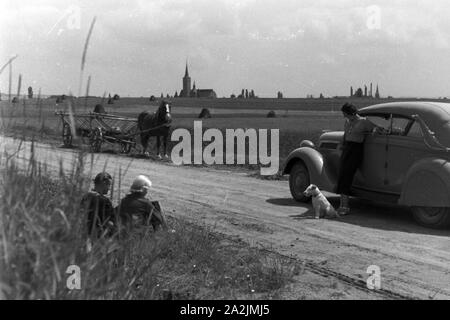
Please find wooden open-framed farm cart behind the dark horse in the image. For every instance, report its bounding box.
[55,112,138,153]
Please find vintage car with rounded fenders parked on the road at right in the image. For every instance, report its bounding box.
[282,102,450,228]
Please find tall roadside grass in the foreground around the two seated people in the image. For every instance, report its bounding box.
[0,146,298,299]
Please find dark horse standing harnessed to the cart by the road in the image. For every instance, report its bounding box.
[138,100,172,158]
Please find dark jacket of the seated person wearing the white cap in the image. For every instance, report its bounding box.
[117,192,166,230]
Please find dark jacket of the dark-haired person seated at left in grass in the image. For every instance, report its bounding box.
[81,190,116,238]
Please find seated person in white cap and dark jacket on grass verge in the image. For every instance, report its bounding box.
[117,175,168,231]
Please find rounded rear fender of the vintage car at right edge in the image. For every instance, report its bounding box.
[399,158,450,207]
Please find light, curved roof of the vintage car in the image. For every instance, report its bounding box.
[359,101,450,145]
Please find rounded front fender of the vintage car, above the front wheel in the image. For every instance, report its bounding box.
[282,147,334,191]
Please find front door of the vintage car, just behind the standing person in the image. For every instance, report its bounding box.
[353,114,390,193]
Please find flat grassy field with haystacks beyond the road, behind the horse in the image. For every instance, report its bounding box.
[0,98,442,174]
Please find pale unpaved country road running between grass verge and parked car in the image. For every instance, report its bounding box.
[0,137,450,299]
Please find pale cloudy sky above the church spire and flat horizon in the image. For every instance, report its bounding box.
[0,0,450,97]
